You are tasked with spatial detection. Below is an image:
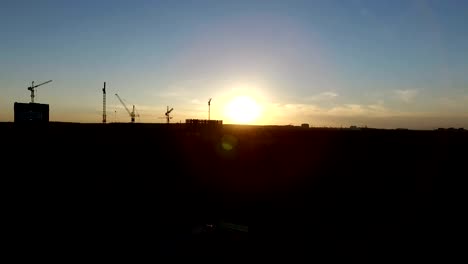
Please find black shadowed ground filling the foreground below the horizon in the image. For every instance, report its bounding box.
[0,123,468,261]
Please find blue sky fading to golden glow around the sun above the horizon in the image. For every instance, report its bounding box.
[0,0,468,129]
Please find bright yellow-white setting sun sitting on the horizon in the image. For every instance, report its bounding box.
[226,96,262,124]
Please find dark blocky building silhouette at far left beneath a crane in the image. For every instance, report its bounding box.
[14,102,49,124]
